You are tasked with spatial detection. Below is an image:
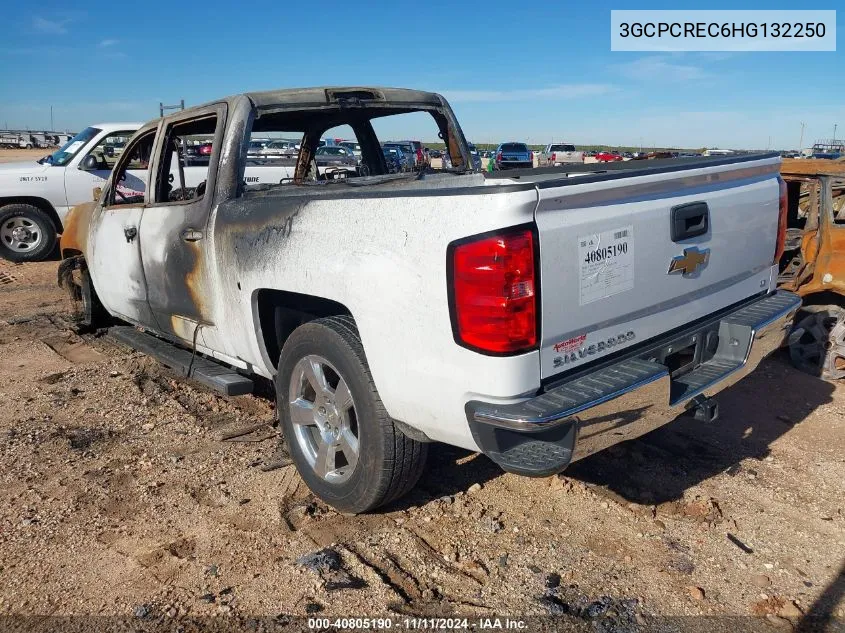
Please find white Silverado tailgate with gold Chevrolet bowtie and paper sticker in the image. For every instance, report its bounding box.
[536,157,779,378]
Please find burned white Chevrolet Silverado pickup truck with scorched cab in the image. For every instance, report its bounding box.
[61,88,799,512]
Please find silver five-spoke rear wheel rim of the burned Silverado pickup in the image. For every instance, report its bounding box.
[288,355,359,483]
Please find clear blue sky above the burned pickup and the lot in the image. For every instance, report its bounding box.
[0,0,845,149]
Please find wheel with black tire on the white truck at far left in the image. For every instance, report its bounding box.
[0,204,56,262]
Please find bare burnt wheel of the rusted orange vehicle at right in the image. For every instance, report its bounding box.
[789,311,845,380]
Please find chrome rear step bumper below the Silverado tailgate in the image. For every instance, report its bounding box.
[466,291,801,476]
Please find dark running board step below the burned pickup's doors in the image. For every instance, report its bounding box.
[109,325,254,396]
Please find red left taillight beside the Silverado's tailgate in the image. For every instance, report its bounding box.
[451,229,537,354]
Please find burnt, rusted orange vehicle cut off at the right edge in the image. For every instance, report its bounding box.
[778,159,845,379]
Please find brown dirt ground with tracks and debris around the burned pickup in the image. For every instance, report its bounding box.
[0,247,845,631]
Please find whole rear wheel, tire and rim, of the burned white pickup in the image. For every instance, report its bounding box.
[276,316,428,514]
